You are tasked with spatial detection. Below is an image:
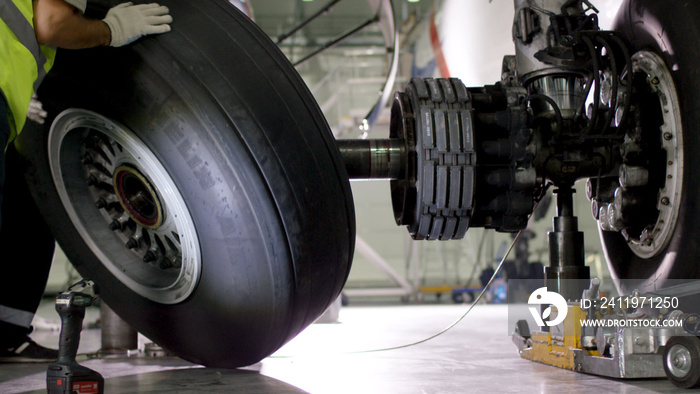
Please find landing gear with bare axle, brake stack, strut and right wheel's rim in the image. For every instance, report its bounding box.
[338,1,668,290]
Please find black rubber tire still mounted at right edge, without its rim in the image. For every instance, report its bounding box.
[600,0,700,294]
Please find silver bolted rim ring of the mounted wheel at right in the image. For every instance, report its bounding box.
[616,51,683,259]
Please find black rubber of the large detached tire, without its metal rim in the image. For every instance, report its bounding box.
[18,0,355,368]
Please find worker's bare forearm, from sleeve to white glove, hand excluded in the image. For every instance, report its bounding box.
[32,0,111,49]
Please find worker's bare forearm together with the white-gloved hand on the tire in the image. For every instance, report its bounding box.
[33,0,173,49]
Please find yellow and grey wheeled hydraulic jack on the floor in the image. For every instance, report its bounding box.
[513,279,700,388]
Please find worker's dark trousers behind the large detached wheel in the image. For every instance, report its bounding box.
[0,94,55,348]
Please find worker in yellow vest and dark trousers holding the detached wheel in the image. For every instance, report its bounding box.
[0,0,172,362]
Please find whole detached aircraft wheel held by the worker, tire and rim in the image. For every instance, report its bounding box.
[17,0,355,368]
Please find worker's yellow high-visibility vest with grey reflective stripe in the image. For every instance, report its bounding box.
[0,0,56,141]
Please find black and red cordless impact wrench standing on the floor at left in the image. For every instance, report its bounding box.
[46,280,104,394]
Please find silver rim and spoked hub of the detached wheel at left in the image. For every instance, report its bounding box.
[48,109,201,304]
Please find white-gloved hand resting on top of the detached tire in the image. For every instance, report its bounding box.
[102,2,173,47]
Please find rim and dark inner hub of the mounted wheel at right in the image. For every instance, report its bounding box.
[587,51,683,258]
